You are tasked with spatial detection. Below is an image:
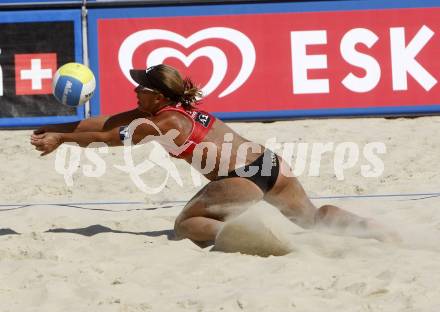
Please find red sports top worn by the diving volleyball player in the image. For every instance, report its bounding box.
[155,104,215,158]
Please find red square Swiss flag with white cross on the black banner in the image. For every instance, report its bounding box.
[14,53,57,95]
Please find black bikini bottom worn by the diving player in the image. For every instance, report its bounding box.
[215,149,280,193]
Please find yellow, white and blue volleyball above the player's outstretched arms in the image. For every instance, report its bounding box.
[52,63,96,107]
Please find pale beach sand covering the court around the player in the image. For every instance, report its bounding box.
[0,117,440,312]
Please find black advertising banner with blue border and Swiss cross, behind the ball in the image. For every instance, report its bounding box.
[0,10,84,126]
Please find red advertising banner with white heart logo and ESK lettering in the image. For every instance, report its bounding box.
[90,1,440,119]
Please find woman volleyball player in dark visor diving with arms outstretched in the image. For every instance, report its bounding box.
[31,65,394,244]
